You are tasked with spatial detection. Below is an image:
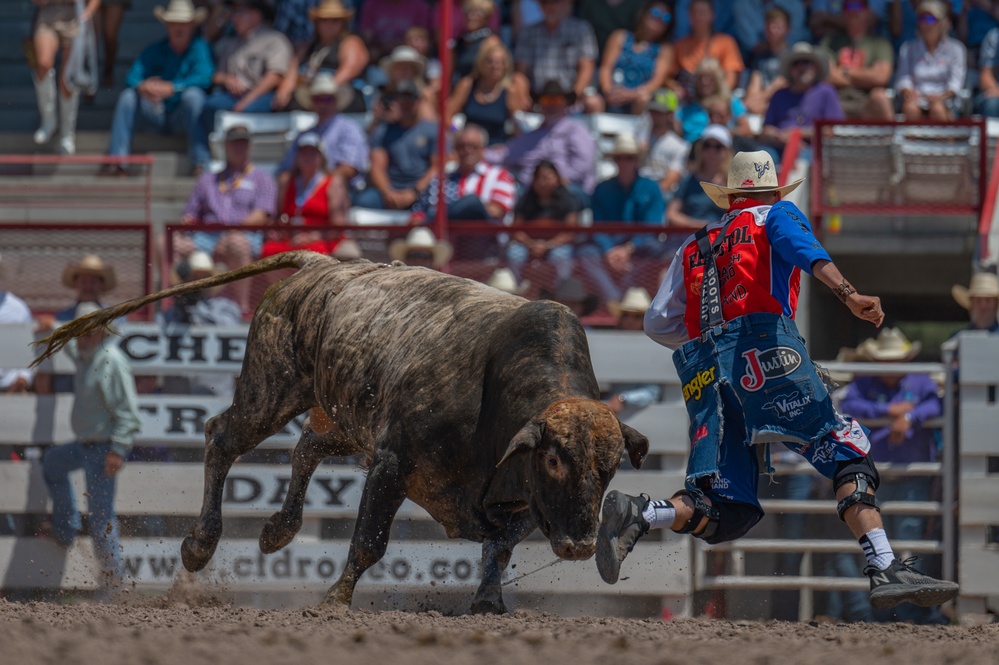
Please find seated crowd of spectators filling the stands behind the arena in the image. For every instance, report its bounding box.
[29,0,999,308]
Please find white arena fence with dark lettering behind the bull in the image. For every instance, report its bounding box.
[0,324,972,619]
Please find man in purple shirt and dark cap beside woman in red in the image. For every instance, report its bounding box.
[174,125,277,311]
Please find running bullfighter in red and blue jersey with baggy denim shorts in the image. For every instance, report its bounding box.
[596,151,958,609]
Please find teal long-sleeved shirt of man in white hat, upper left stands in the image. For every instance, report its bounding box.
[125,36,215,113]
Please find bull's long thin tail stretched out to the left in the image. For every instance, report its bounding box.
[31,250,337,367]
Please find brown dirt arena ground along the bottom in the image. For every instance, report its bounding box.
[0,598,999,665]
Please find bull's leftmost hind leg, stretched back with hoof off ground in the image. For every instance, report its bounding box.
[180,312,316,572]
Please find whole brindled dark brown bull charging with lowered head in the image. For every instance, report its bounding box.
[38,251,649,613]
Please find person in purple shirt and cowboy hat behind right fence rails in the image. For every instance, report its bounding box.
[841,328,946,623]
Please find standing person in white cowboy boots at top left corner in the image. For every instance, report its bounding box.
[28,0,101,155]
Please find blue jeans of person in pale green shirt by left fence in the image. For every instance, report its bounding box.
[42,442,122,579]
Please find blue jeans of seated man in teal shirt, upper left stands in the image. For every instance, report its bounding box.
[108,88,205,164]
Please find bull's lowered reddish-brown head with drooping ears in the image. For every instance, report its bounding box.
[499,399,649,559]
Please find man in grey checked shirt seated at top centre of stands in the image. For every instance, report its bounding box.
[513,0,603,113]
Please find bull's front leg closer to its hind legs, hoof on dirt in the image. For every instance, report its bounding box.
[323,446,407,610]
